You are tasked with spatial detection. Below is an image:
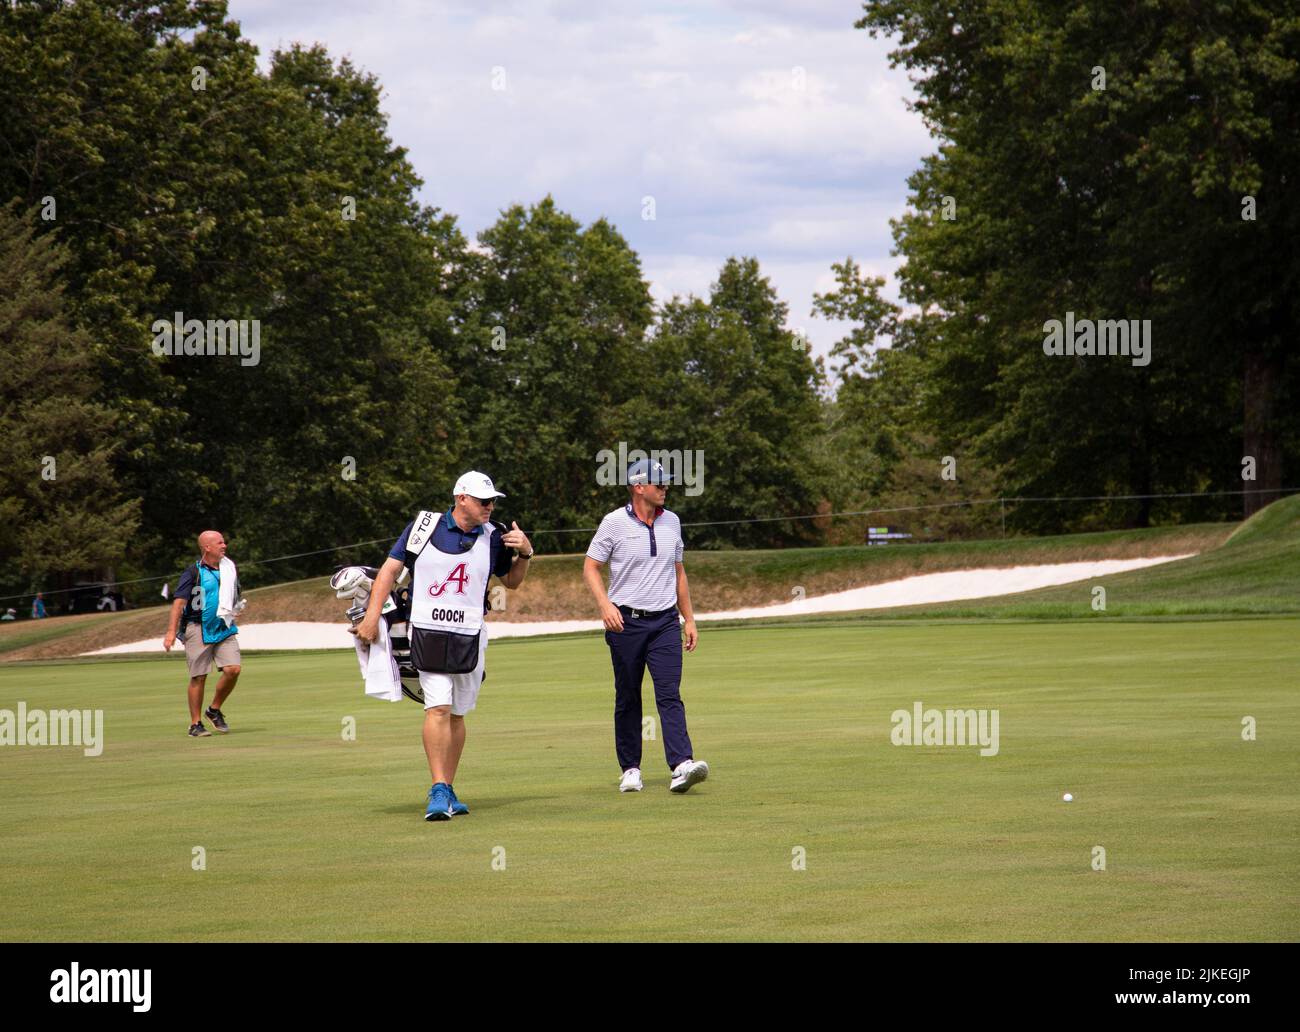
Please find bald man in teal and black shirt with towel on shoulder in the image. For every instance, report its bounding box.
[163,530,242,738]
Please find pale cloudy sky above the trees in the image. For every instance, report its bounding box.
[230,0,933,366]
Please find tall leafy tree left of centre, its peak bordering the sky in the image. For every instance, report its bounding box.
[210,47,465,569]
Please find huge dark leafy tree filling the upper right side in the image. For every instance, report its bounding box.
[858,0,1300,526]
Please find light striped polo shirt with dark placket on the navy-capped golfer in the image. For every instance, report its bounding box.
[586,506,683,612]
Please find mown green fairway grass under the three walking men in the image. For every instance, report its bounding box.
[0,619,1300,941]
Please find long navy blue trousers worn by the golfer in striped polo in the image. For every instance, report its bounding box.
[605,610,692,771]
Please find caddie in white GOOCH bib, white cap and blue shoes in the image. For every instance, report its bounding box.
[356,471,533,820]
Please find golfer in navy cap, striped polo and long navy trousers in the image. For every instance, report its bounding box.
[582,460,709,792]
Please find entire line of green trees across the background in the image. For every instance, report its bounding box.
[0,0,1300,603]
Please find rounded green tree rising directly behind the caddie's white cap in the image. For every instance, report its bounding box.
[457,196,653,547]
